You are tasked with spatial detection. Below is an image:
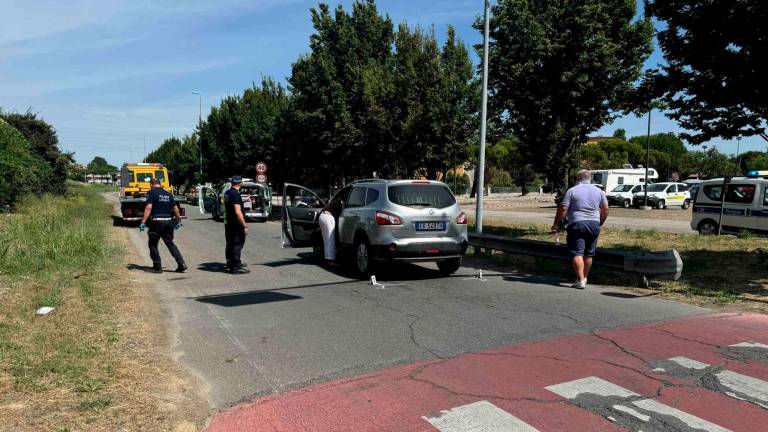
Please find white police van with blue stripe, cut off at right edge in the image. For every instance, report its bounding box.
[691,177,768,234]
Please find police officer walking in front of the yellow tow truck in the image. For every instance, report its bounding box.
[139,178,187,273]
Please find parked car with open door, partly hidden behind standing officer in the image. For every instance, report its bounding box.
[198,179,272,222]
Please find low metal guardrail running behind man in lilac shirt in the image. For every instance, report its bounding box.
[469,233,683,285]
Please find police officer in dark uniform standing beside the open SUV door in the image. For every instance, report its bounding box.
[224,176,250,274]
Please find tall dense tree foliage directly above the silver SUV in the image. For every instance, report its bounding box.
[289,0,477,184]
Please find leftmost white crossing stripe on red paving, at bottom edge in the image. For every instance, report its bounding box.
[422,401,539,432]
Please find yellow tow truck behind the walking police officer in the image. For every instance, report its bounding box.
[119,163,187,222]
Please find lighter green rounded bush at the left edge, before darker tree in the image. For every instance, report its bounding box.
[0,119,51,210]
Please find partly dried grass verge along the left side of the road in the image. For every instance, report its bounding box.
[0,183,205,431]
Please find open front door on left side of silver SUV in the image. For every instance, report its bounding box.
[281,183,325,247]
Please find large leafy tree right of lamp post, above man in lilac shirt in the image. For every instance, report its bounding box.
[484,0,653,187]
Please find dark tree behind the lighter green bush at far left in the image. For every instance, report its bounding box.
[0,110,74,194]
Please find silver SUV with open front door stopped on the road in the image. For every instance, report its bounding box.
[282,179,468,276]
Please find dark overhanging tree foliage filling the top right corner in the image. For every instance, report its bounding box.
[644,0,768,144]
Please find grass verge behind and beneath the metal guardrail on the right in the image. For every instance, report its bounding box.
[472,220,768,310]
